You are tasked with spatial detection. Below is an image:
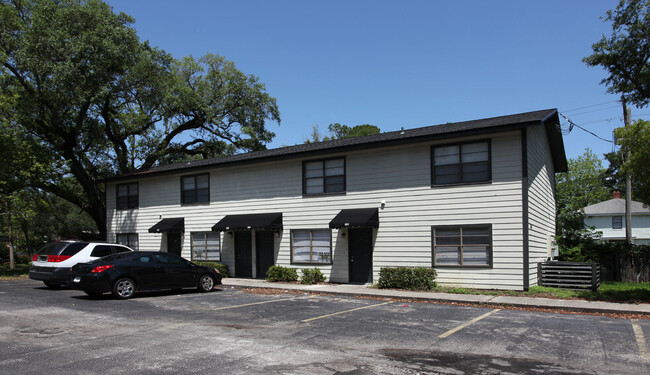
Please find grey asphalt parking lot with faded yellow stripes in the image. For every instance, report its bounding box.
[0,280,650,374]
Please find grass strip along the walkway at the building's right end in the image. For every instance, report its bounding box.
[431,281,650,303]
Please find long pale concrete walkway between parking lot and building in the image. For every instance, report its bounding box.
[222,278,650,315]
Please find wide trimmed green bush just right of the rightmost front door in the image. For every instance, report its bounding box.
[378,267,437,290]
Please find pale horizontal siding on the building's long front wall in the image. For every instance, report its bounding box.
[107,131,523,289]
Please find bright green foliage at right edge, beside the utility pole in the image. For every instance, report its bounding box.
[614,120,650,204]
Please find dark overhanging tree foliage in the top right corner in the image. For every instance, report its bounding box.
[583,0,650,107]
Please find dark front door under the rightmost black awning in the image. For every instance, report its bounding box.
[348,228,372,284]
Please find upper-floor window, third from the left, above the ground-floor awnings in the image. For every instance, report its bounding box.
[302,158,345,195]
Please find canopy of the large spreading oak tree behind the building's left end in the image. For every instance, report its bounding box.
[0,0,280,238]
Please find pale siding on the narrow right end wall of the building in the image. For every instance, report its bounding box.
[527,125,555,286]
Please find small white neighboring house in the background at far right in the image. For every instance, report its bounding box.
[584,191,650,245]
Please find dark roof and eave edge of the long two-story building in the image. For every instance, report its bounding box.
[105,109,567,181]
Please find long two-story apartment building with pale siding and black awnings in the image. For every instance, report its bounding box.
[106,109,567,290]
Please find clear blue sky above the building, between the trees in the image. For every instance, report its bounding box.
[108,0,650,165]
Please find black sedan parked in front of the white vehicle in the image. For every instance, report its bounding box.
[68,251,221,299]
